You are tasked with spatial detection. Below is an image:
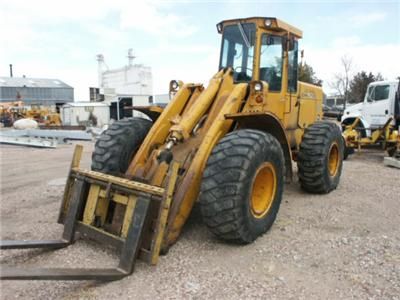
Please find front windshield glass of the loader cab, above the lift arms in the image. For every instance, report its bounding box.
[219,23,256,81]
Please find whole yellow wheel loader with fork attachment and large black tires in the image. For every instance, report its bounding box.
[0,17,343,280]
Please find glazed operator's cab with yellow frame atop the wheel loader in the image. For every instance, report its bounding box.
[217,17,302,93]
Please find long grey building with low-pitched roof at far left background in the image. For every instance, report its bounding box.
[0,77,74,107]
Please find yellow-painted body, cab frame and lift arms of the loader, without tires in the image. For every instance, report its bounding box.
[60,18,322,252]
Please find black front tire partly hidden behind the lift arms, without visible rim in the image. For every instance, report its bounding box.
[92,118,152,176]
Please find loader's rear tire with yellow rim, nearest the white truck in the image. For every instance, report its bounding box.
[297,122,344,194]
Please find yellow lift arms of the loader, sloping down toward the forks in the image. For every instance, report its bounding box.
[126,71,247,245]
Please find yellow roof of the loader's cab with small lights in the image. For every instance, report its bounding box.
[217,17,303,38]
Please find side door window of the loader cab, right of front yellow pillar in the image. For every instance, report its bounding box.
[260,34,282,92]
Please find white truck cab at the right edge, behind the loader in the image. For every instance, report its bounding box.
[341,81,400,136]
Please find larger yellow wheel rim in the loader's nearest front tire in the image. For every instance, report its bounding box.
[250,162,277,218]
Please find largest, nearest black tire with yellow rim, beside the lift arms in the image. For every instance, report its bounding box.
[199,129,285,243]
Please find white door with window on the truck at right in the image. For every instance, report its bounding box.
[362,84,392,128]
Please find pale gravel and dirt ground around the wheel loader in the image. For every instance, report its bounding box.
[0,142,400,299]
